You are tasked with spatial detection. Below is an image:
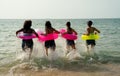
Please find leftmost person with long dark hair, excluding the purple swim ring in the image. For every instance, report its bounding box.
[16,20,38,59]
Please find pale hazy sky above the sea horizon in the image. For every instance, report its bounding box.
[0,0,120,19]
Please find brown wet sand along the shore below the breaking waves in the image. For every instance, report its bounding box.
[0,63,120,76]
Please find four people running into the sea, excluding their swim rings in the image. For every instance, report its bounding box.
[16,20,100,58]
